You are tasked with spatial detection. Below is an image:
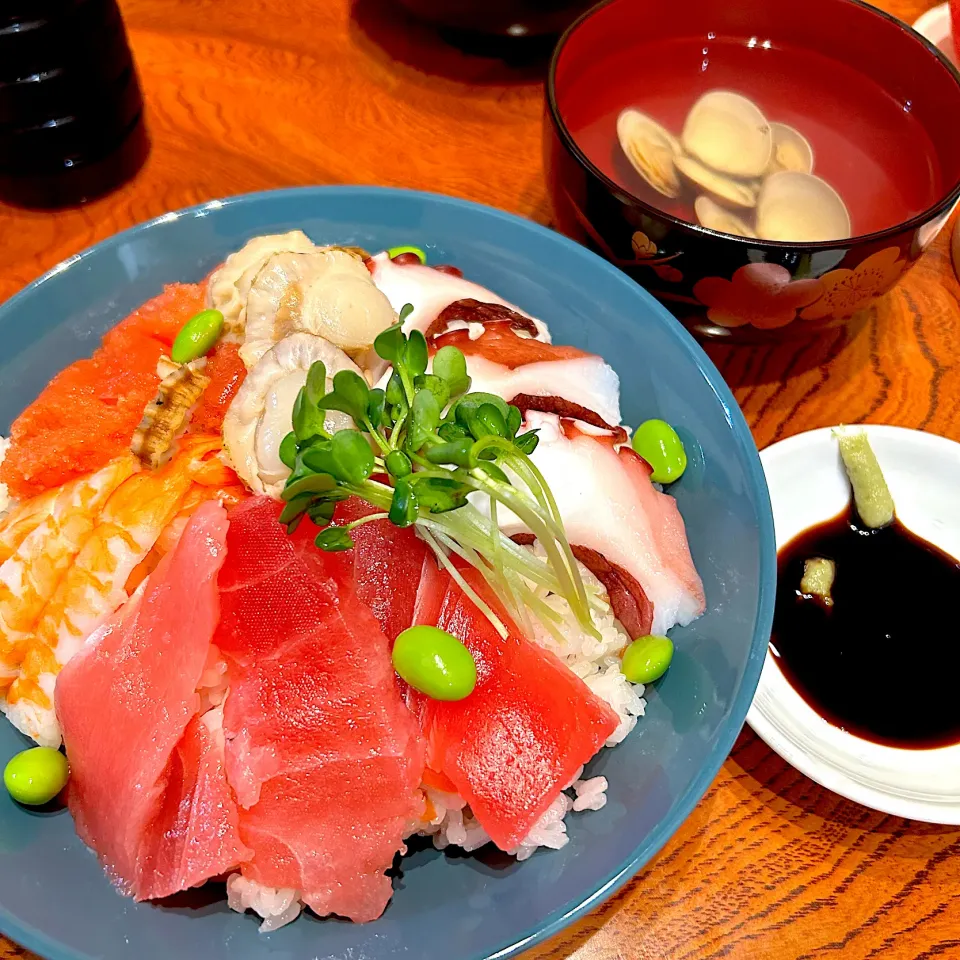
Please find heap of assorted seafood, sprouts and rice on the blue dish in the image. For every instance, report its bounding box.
[0,230,706,931]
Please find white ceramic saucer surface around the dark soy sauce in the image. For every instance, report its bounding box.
[747,425,960,824]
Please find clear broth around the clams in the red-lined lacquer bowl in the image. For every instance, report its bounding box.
[563,37,943,235]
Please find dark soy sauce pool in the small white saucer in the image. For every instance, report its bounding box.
[770,508,960,750]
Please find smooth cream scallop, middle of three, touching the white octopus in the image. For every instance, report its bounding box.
[240,247,397,368]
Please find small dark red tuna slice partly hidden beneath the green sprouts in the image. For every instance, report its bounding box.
[334,497,430,644]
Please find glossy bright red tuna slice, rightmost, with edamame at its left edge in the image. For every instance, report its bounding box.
[412,570,617,850]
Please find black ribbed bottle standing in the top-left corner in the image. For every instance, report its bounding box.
[0,0,147,206]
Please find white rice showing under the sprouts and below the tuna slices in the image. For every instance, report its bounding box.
[227,545,646,933]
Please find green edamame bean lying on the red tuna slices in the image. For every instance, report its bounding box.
[393,626,477,700]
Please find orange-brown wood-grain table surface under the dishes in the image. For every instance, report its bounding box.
[0,0,960,960]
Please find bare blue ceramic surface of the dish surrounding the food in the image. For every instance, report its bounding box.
[0,187,775,960]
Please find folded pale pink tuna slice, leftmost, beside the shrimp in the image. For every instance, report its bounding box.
[56,503,246,900]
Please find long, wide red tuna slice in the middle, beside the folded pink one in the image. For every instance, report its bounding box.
[215,497,423,921]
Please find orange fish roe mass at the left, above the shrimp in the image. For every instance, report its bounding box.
[0,284,204,500]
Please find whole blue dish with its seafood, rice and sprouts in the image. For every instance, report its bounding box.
[0,188,774,958]
